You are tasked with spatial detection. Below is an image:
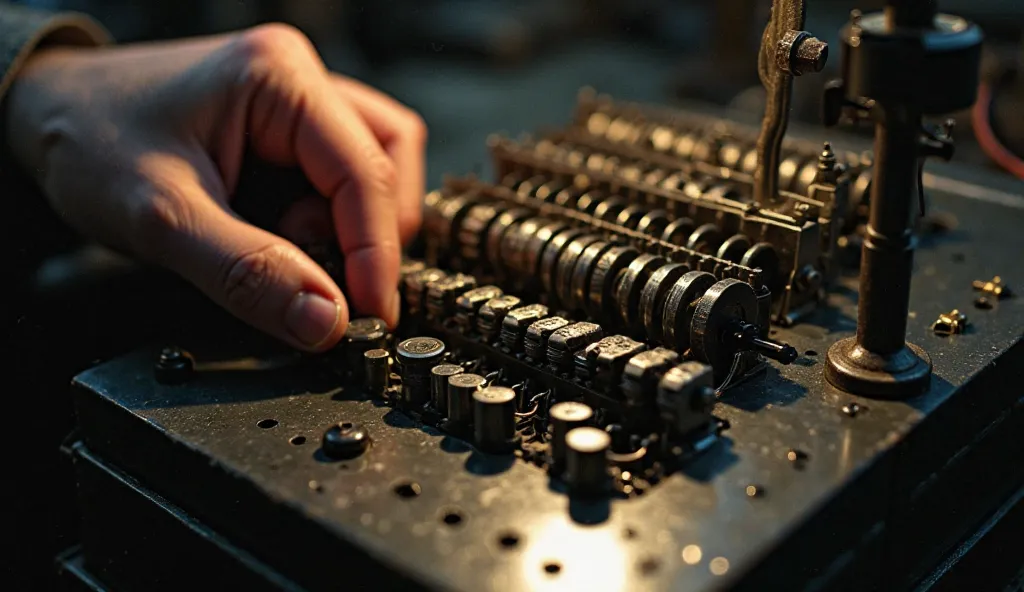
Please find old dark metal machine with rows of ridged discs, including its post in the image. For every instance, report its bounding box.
[61,0,1024,590]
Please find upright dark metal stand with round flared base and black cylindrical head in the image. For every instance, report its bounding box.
[825,0,981,397]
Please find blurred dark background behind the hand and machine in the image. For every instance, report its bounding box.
[8,0,1024,590]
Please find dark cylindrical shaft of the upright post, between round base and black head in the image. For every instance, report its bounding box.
[857,109,921,354]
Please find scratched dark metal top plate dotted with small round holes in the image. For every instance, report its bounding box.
[77,167,1024,590]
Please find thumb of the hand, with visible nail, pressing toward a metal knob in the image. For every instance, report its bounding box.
[142,167,348,351]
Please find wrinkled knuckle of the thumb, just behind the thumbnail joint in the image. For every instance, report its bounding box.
[221,245,291,313]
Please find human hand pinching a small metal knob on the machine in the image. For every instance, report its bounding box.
[5,25,426,350]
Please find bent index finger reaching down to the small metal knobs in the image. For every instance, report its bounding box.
[237,27,400,326]
